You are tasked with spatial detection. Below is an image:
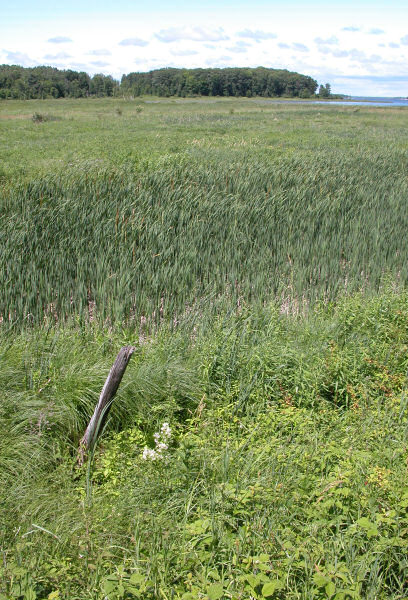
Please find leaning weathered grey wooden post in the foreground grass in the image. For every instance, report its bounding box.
[78,346,136,465]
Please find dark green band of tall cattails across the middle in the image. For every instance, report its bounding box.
[0,150,408,324]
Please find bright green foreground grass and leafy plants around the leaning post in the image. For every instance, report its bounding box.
[0,290,408,600]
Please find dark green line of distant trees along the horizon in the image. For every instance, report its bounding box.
[0,65,330,100]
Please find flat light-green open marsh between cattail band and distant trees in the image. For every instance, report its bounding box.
[0,98,408,178]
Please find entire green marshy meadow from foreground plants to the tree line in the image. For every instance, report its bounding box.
[0,98,408,600]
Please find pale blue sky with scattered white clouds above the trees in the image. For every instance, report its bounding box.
[0,0,408,97]
